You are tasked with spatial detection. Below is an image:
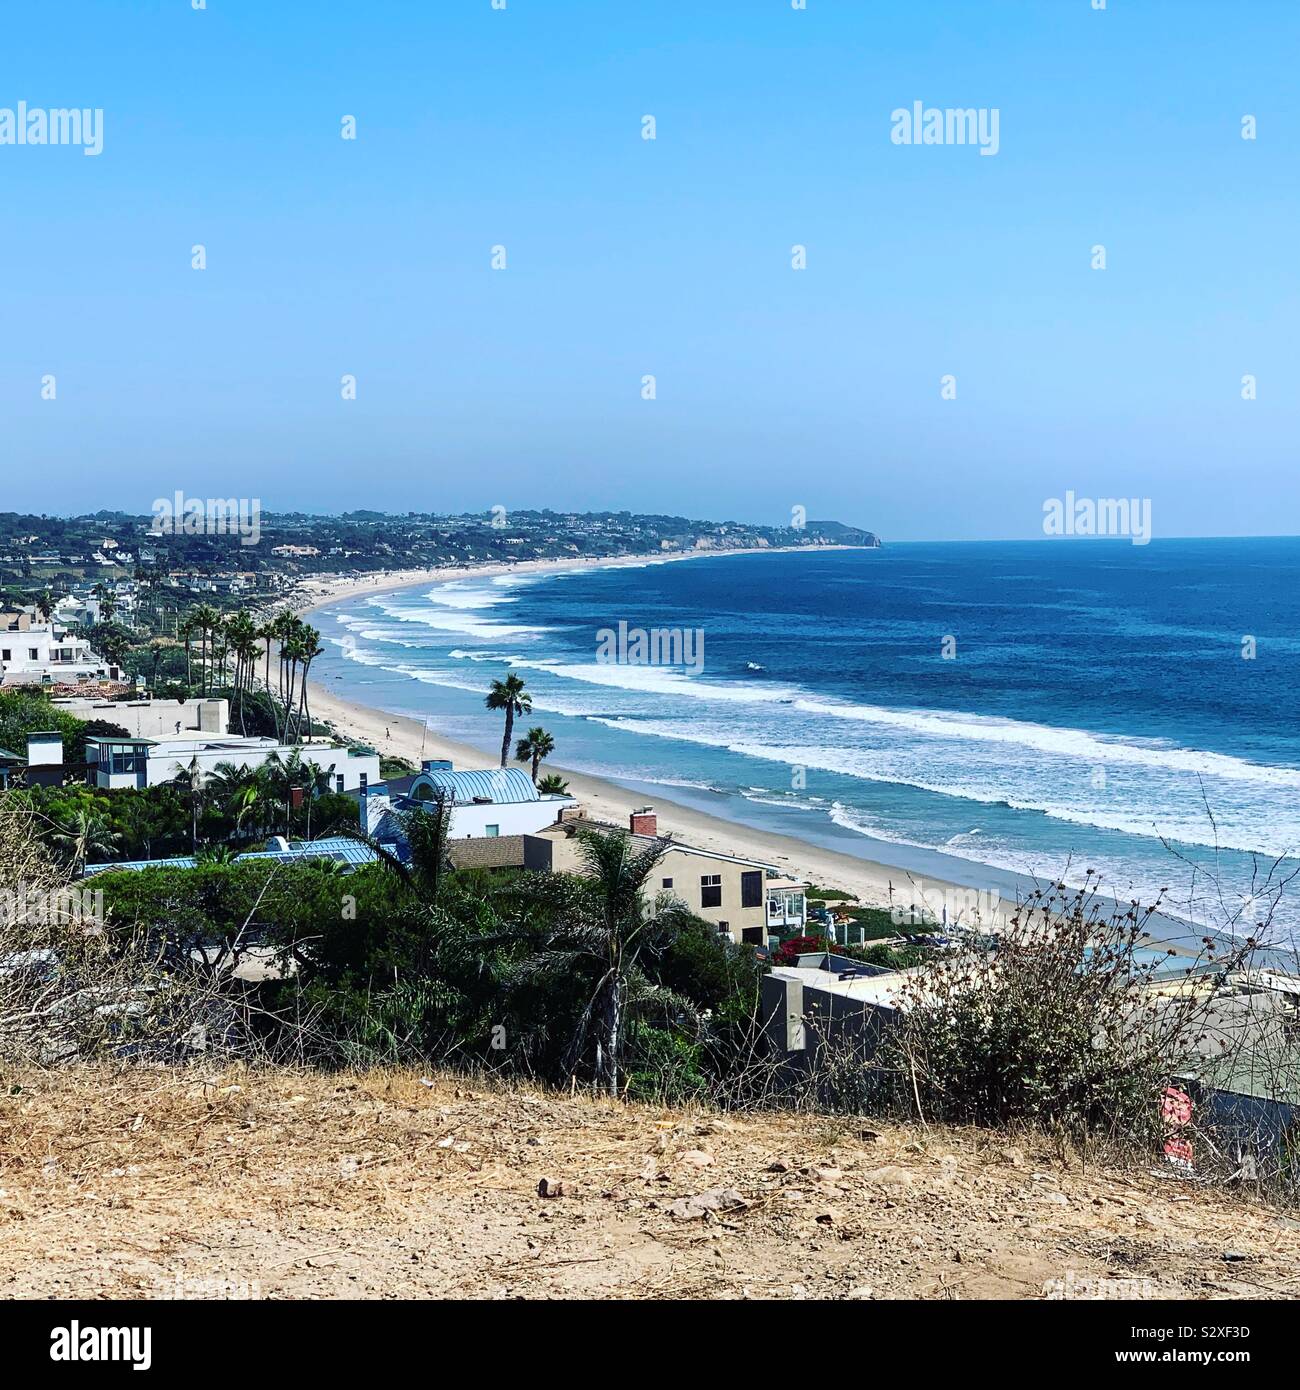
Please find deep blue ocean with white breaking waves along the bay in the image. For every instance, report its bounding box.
[313,539,1300,934]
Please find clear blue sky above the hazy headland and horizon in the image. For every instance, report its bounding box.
[0,0,1300,539]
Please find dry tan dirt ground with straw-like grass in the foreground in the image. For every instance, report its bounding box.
[0,1069,1300,1300]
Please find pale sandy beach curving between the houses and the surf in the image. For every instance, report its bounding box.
[295,546,1006,908]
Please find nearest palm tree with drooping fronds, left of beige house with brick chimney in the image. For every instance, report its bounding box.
[516,830,695,1095]
